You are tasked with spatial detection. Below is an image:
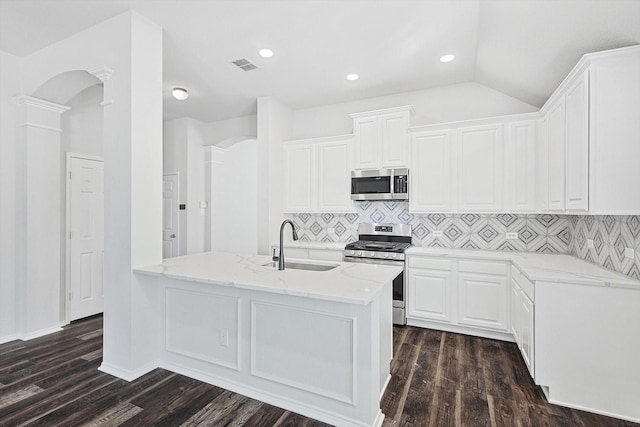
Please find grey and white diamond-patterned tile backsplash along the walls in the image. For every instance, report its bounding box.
[292,201,640,280]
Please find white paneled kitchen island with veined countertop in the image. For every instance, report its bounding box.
[134,252,402,426]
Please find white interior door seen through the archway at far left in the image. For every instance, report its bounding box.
[68,157,104,321]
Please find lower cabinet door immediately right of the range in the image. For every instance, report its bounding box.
[407,269,455,322]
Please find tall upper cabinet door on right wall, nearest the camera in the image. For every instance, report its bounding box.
[565,70,589,211]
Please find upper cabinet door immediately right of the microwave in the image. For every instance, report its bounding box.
[409,130,454,212]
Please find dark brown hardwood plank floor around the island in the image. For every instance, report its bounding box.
[0,316,638,427]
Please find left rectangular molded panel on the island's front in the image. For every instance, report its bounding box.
[165,288,241,371]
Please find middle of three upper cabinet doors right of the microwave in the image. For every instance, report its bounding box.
[456,124,503,212]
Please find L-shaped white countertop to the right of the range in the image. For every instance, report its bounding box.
[406,246,640,290]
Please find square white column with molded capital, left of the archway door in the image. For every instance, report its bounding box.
[16,95,69,340]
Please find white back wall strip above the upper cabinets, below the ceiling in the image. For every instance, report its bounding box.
[292,82,538,139]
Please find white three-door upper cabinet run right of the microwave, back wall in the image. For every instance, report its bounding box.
[409,113,538,213]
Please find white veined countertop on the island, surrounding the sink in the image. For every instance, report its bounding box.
[133,252,402,305]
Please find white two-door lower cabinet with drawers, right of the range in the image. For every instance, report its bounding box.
[407,255,511,340]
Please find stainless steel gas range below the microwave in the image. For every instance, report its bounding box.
[344,223,411,325]
